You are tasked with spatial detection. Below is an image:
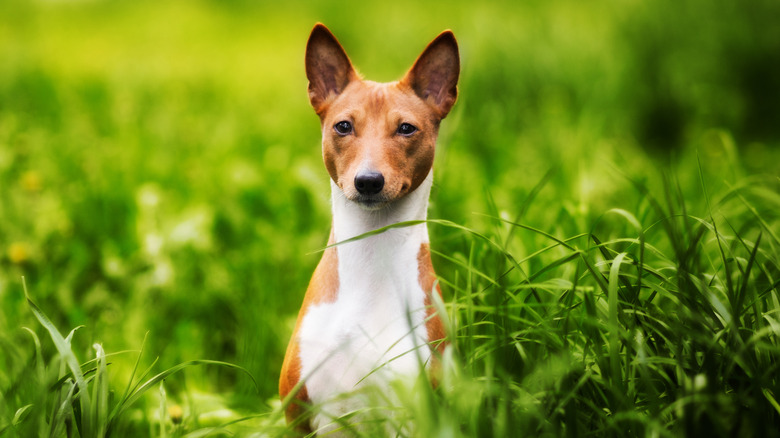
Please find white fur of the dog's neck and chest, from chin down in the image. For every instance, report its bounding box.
[298,174,432,429]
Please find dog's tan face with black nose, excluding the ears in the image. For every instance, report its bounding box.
[322,81,439,208]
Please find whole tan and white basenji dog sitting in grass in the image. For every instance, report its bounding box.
[279,24,460,433]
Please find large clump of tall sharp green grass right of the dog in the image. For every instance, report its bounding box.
[420,170,780,436]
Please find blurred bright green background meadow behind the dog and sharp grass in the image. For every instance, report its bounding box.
[0,0,780,432]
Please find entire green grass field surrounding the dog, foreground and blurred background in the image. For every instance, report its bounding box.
[0,0,780,438]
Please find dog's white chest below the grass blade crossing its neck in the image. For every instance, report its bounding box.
[299,233,430,404]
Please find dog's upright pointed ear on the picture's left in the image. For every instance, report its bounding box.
[306,23,359,115]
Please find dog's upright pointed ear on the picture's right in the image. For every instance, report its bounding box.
[401,30,460,119]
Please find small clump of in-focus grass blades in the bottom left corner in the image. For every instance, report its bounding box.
[0,278,262,437]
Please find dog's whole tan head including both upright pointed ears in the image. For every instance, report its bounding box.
[306,24,460,210]
